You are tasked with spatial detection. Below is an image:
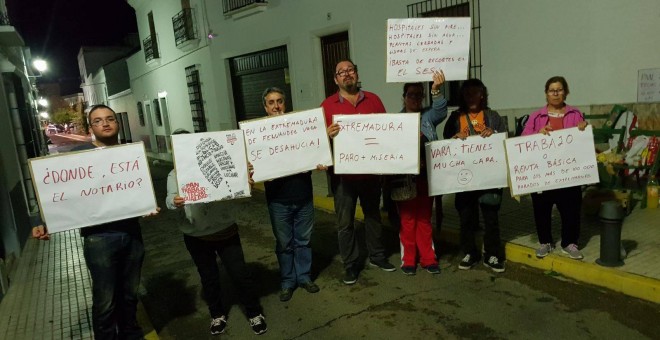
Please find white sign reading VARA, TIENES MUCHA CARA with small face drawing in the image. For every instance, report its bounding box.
[426,133,508,196]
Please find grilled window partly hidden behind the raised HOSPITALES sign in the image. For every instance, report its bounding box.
[408,0,482,106]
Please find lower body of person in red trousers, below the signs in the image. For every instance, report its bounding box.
[397,176,438,267]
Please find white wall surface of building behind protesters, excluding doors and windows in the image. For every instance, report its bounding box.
[128,0,660,138]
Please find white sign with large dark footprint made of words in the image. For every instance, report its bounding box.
[172,130,250,204]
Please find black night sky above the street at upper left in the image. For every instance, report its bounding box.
[6,0,137,94]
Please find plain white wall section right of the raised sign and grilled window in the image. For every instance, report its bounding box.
[481,0,660,108]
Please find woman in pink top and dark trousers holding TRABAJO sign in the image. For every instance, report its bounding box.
[522,76,587,260]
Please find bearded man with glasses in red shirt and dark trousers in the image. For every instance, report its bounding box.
[321,60,396,285]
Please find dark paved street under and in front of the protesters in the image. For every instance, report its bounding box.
[142,166,660,339]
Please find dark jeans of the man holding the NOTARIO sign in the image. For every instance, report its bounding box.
[84,232,144,340]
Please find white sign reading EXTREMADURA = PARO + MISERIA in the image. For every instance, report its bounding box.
[332,113,419,174]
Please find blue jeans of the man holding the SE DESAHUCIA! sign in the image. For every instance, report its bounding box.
[268,200,314,289]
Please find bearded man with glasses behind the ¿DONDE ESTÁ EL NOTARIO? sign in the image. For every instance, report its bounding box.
[32,105,158,339]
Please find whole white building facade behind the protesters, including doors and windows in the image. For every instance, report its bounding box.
[128,0,660,159]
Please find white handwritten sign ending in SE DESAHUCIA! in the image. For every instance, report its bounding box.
[239,108,332,182]
